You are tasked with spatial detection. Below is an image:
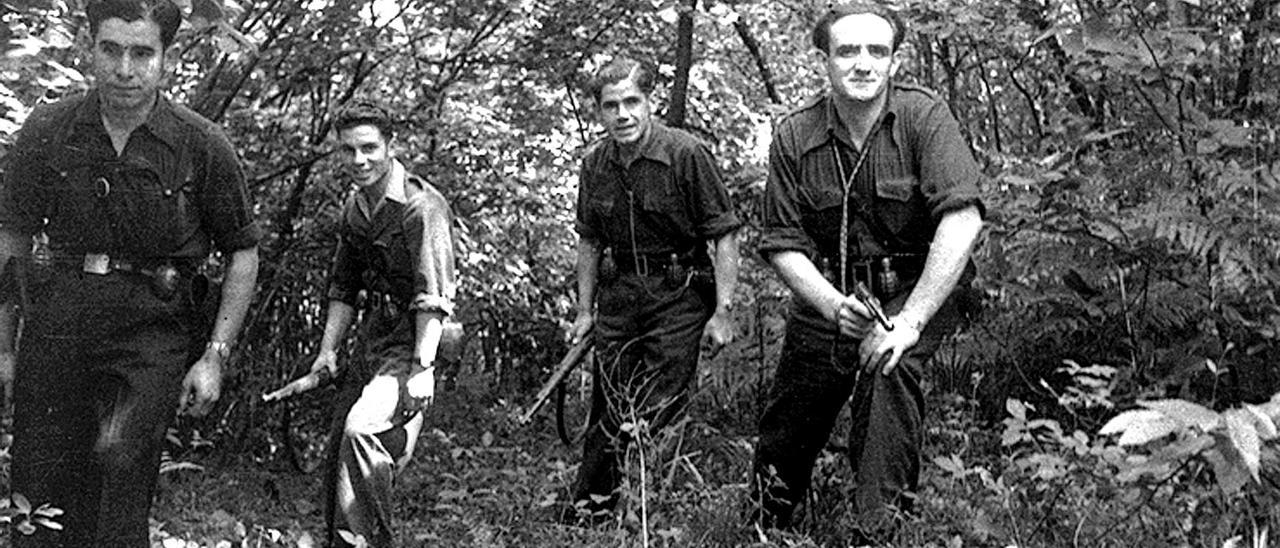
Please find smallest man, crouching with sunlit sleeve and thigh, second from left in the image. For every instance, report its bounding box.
[303,101,457,548]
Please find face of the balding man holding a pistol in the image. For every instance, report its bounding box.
[824,14,899,102]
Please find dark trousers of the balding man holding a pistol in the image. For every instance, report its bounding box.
[753,290,959,534]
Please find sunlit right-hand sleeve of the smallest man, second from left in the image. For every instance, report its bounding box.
[404,189,457,315]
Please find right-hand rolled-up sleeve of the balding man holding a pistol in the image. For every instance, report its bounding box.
[915,101,986,219]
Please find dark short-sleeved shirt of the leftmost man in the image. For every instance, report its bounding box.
[0,91,261,259]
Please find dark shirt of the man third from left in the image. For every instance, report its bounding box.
[576,123,741,264]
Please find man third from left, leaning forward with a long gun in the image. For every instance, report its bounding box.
[564,58,741,517]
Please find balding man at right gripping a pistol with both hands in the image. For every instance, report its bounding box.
[754,4,983,543]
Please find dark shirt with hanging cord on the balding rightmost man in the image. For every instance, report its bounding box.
[759,85,983,259]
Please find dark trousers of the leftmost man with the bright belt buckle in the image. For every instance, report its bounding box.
[12,269,204,548]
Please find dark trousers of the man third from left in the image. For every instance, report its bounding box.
[573,274,714,511]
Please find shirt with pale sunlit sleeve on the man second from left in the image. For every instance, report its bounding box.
[329,161,457,315]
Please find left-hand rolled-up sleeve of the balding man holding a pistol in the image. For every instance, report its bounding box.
[758,120,817,260]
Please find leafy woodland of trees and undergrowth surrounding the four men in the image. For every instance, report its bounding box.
[0,0,1280,547]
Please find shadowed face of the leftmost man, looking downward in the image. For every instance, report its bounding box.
[93,18,168,111]
